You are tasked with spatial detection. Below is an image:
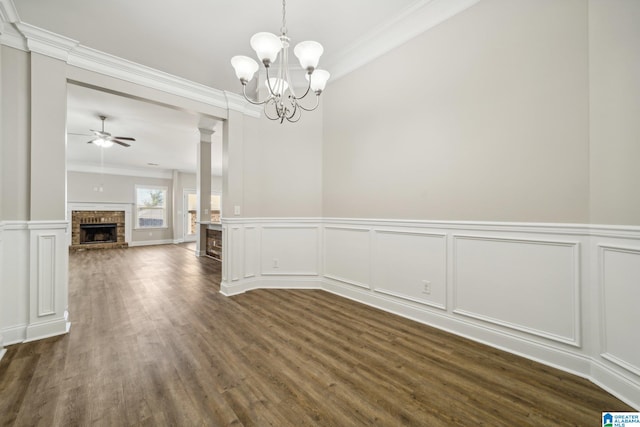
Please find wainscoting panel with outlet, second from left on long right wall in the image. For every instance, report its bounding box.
[372,230,447,309]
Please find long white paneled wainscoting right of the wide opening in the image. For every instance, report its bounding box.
[221,218,640,408]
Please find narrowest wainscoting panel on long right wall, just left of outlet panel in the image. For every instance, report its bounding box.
[324,226,371,288]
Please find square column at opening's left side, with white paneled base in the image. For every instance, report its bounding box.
[26,51,69,341]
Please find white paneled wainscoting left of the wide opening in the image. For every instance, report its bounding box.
[0,221,69,345]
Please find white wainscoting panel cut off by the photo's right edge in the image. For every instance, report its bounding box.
[599,245,640,376]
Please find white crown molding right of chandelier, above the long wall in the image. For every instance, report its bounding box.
[323,0,480,81]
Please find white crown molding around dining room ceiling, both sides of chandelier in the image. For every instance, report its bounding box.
[0,0,480,111]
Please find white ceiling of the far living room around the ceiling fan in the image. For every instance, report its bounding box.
[67,84,222,175]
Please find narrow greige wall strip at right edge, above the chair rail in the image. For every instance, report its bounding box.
[589,0,640,225]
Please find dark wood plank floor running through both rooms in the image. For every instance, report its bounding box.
[0,246,633,426]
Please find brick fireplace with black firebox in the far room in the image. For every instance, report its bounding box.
[70,211,128,250]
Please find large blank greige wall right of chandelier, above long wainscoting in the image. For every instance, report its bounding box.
[323,0,589,223]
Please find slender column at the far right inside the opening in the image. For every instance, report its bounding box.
[196,128,214,256]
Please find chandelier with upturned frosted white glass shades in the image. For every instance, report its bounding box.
[231,0,330,123]
